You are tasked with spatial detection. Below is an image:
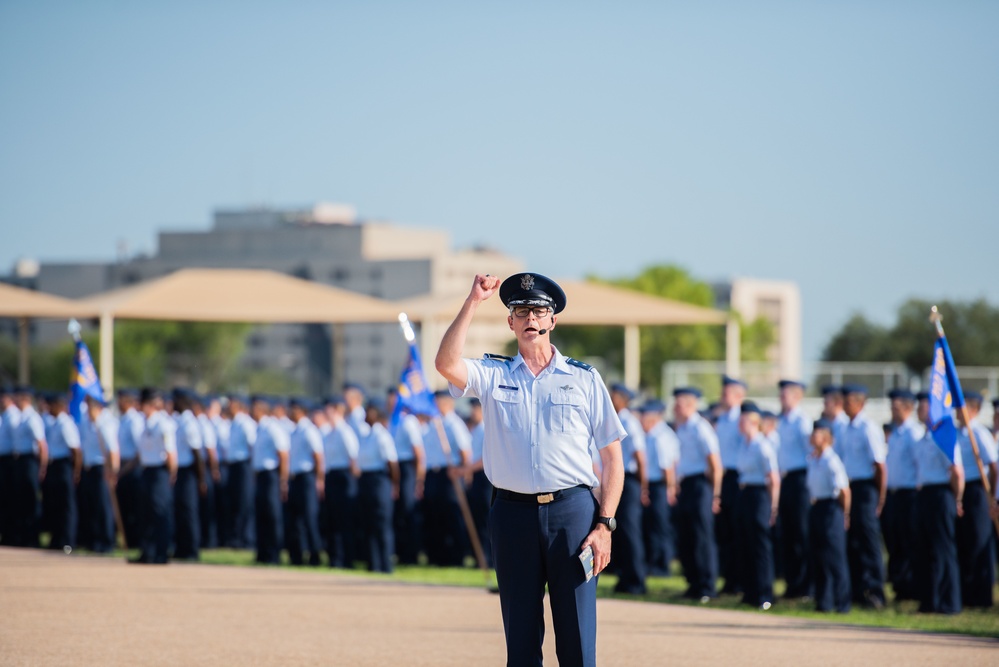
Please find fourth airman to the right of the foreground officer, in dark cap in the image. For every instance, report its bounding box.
[715,375,746,595]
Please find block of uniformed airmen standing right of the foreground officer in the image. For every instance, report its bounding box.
[611,377,999,613]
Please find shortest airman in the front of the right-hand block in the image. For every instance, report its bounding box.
[806,418,851,614]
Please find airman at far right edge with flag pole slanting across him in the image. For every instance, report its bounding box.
[957,391,999,607]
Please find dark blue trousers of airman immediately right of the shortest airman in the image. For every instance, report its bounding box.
[846,480,885,604]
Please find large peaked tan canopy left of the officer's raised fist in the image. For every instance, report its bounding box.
[80,269,399,392]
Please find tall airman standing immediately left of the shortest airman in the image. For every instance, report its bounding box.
[777,379,812,599]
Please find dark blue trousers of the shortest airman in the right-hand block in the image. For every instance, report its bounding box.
[808,499,850,614]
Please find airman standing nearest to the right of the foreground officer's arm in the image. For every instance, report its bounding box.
[610,382,649,595]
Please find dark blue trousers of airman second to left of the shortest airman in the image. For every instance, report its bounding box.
[737,486,774,607]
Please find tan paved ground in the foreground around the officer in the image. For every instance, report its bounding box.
[0,549,999,667]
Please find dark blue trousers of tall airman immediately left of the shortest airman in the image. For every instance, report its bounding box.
[777,470,812,598]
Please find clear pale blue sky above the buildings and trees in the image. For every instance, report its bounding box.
[0,0,999,358]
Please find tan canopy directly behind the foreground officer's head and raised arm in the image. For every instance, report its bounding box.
[397,280,740,387]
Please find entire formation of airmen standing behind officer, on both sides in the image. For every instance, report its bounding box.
[0,377,999,613]
